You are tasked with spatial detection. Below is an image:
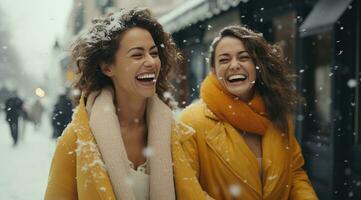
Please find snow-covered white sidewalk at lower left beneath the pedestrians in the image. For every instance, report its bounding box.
[0,113,56,200]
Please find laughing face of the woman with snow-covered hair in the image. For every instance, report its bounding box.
[102,27,161,98]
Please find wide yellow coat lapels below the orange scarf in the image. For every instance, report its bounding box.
[204,101,291,199]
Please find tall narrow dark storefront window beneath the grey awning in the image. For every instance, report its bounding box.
[302,32,330,135]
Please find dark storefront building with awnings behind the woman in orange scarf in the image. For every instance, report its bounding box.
[159,0,361,200]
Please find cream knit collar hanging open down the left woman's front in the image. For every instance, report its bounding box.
[81,89,175,200]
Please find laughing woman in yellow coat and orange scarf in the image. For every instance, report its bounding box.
[173,25,317,200]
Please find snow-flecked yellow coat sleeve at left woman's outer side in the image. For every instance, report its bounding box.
[45,125,78,200]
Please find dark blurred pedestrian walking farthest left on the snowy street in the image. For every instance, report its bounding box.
[5,95,28,146]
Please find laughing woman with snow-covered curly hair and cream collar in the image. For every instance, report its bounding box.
[45,9,186,200]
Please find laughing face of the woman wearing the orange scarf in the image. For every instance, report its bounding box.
[213,36,256,102]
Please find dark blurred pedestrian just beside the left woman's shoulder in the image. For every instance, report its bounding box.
[51,94,73,139]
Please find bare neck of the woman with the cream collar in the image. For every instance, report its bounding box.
[115,91,147,127]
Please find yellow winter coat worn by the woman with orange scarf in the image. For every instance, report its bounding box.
[172,101,318,200]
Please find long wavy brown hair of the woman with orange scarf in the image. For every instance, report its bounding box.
[210,25,304,132]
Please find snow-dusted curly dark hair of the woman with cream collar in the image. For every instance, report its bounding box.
[72,8,182,105]
